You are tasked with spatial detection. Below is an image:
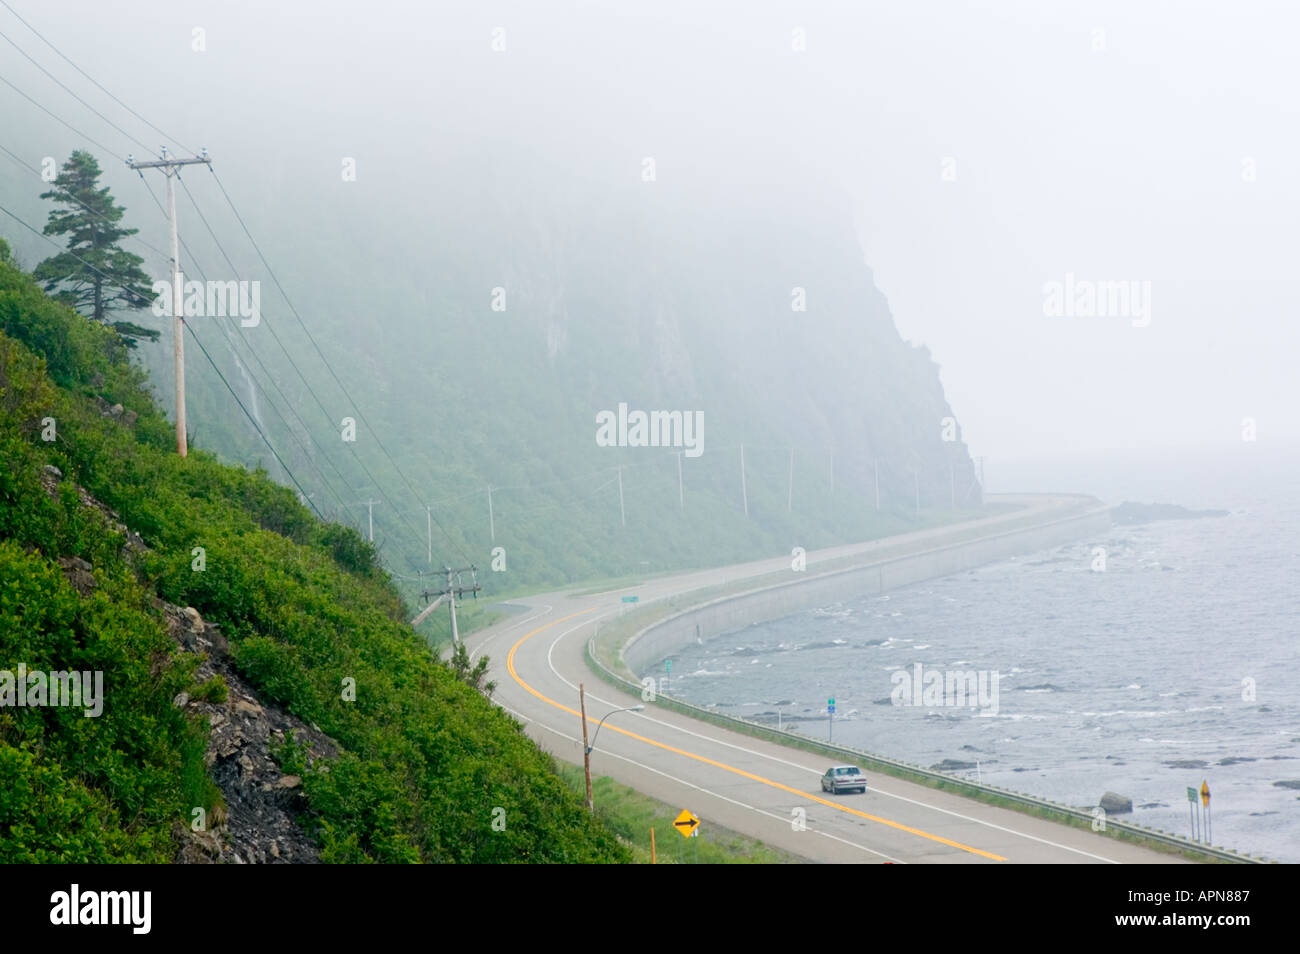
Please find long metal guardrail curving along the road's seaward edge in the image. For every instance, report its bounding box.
[585,511,1271,864]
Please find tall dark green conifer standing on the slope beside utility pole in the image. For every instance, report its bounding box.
[33,149,159,347]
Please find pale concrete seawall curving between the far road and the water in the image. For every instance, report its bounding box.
[623,498,1110,675]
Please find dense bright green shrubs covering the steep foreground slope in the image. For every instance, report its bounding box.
[0,243,628,862]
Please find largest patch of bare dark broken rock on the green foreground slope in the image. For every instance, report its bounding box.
[163,603,338,864]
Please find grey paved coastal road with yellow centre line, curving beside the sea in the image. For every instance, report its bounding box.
[468,498,1174,864]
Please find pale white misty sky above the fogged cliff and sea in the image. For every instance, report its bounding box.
[0,0,1300,460]
